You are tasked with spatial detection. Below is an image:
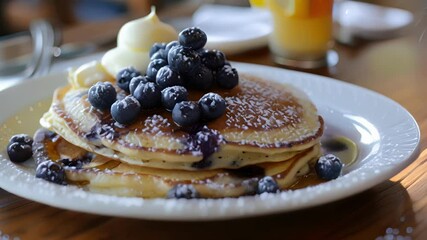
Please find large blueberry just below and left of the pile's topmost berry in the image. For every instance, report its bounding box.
[168,46,201,74]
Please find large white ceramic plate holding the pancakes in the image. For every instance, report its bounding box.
[0,63,420,220]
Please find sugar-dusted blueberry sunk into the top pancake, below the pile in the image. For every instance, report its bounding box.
[187,126,224,158]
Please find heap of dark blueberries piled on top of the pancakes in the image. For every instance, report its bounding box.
[88,27,239,127]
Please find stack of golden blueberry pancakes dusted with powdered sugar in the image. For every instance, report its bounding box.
[35,75,323,198]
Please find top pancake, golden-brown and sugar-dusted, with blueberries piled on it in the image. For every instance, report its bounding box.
[40,75,323,171]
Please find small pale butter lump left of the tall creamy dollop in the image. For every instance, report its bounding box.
[68,61,114,88]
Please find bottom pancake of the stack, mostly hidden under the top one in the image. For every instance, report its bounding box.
[33,129,320,198]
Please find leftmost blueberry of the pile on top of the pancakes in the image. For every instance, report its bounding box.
[88,82,117,110]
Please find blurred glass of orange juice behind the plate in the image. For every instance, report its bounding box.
[250,0,333,68]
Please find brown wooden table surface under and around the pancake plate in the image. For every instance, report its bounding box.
[0,0,427,239]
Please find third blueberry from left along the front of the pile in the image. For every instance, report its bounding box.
[133,82,161,109]
